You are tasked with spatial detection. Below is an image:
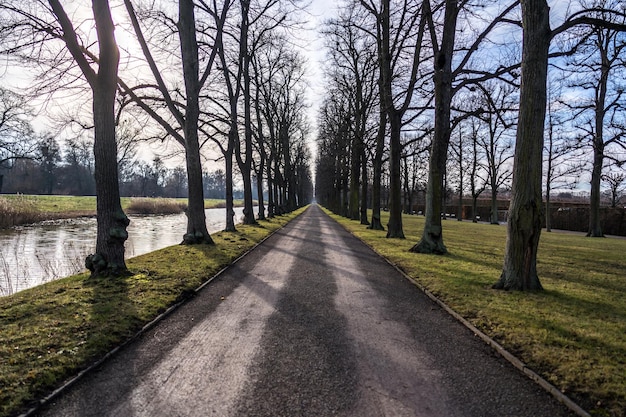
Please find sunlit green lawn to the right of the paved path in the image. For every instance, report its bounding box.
[326,208,626,417]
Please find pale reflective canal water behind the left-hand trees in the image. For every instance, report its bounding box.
[0,208,243,296]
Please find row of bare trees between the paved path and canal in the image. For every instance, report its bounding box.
[0,0,312,275]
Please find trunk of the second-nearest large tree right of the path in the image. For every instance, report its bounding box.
[410,0,459,254]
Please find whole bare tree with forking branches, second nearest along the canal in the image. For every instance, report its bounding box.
[120,0,231,244]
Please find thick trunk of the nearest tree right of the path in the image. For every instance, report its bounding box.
[493,0,550,291]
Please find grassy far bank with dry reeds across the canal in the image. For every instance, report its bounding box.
[0,194,249,229]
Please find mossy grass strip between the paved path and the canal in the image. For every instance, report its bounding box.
[0,210,302,416]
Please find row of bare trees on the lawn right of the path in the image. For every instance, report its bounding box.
[316,0,626,289]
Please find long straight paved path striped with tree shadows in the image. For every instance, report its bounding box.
[35,206,570,417]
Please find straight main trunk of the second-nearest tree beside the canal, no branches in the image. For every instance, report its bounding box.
[178,0,213,244]
